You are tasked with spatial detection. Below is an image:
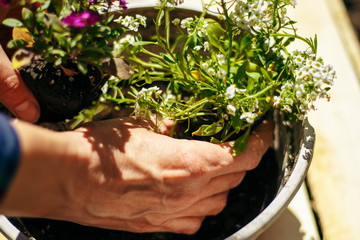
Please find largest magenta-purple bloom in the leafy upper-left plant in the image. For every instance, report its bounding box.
[61,10,101,28]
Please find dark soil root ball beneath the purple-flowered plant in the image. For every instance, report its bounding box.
[19,60,105,122]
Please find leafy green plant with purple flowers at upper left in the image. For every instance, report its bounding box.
[1,0,129,74]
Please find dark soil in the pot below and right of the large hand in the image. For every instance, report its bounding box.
[10,149,280,240]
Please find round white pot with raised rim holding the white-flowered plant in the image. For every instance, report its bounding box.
[0,1,315,240]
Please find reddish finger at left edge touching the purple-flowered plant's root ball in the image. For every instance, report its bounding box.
[0,46,40,122]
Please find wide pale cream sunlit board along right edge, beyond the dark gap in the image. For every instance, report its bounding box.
[294,0,360,240]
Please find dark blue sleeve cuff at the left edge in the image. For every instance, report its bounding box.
[0,113,20,200]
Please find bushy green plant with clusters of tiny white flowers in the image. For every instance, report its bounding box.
[100,0,336,155]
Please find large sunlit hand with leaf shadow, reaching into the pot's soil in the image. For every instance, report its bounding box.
[2,118,273,234]
